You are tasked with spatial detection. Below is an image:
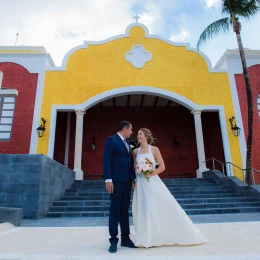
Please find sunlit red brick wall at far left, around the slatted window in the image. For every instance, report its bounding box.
[0,62,38,154]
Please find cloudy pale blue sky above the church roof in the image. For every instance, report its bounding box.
[0,0,260,66]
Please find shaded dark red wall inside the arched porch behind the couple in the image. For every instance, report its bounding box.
[54,107,223,177]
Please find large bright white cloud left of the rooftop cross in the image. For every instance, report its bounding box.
[0,0,137,65]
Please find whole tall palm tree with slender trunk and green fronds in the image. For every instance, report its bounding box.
[197,0,260,184]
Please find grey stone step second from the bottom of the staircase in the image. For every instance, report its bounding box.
[50,202,260,212]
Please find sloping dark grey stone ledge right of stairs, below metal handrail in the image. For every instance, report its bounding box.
[202,170,260,199]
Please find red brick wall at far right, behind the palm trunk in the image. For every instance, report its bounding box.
[235,65,260,183]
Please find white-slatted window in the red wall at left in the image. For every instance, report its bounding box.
[0,96,16,142]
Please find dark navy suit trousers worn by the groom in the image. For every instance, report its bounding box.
[109,180,132,244]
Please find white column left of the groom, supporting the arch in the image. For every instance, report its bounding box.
[74,110,85,180]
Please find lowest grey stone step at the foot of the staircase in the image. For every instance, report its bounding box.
[47,207,260,218]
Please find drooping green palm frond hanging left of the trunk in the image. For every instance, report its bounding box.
[197,17,231,51]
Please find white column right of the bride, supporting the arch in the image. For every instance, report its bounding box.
[192,110,208,178]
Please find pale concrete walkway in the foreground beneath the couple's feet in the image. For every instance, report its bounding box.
[0,221,260,260]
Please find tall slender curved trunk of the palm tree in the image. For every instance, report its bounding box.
[233,19,253,185]
